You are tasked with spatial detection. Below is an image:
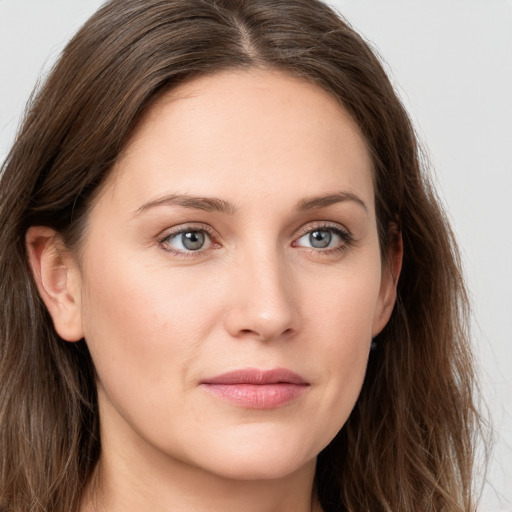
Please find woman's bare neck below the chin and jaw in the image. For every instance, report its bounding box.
[81,456,322,512]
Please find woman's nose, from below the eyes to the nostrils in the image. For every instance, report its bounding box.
[224,252,301,341]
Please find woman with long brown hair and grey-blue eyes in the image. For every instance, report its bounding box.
[0,0,479,512]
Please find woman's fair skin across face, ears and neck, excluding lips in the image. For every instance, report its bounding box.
[27,70,401,512]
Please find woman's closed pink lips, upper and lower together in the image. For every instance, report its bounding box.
[200,368,310,409]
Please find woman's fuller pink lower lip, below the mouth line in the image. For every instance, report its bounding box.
[201,382,309,409]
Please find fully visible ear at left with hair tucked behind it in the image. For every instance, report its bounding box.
[25,226,83,341]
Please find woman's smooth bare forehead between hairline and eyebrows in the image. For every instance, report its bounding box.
[100,70,373,217]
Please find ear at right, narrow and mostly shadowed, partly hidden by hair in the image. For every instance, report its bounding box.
[372,224,404,337]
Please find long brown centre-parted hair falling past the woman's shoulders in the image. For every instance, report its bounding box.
[0,0,486,512]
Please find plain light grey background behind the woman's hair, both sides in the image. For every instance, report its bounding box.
[0,0,512,512]
